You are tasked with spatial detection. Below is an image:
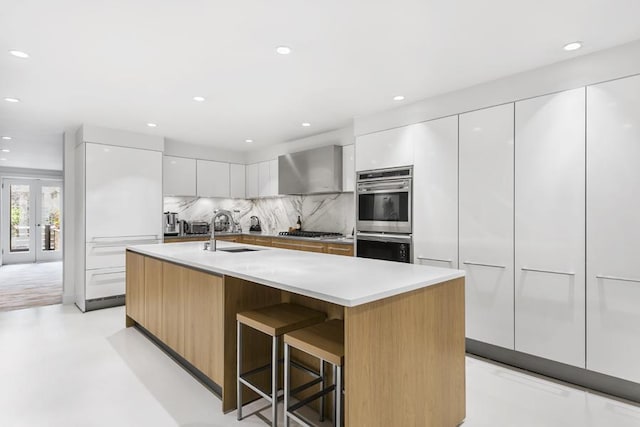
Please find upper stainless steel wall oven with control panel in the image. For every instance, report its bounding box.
[356,167,413,233]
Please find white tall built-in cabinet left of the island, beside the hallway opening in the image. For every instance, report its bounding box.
[74,127,164,311]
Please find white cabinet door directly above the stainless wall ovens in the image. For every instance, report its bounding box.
[356,124,420,171]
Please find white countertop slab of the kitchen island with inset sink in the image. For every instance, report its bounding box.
[128,241,464,307]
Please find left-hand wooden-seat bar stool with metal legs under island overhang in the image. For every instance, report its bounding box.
[236,304,326,427]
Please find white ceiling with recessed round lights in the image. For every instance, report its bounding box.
[0,0,640,169]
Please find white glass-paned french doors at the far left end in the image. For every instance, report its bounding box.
[0,179,62,264]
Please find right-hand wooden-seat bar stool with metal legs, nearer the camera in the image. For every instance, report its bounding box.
[284,320,344,427]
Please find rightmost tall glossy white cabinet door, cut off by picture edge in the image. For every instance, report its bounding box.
[587,76,640,383]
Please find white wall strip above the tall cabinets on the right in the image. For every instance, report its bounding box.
[354,40,640,135]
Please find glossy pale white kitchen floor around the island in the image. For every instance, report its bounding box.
[0,305,640,427]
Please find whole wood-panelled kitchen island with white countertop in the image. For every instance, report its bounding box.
[126,242,465,427]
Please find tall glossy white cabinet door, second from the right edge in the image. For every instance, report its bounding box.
[515,88,585,368]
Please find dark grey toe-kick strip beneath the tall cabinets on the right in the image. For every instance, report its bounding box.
[466,338,640,403]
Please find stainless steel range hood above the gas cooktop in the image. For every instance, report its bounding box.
[278,145,342,194]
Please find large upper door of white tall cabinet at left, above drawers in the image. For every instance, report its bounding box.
[85,143,163,242]
